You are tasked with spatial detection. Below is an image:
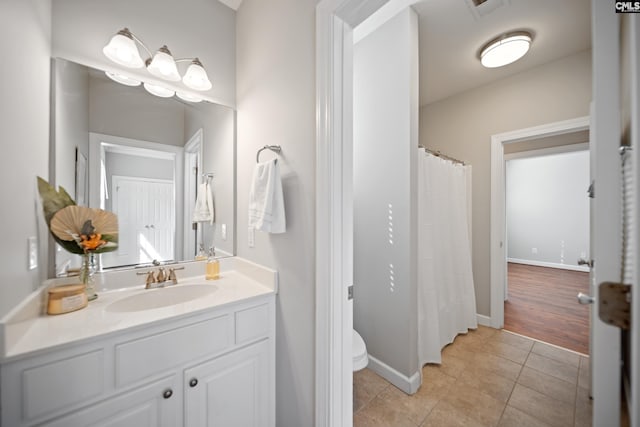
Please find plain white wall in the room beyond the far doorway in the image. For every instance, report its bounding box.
[505,151,589,267]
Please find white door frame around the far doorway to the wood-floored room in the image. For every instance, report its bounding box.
[490,116,590,329]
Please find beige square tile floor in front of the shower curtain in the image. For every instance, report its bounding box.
[353,326,591,427]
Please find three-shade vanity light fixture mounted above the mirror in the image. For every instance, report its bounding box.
[102,28,211,91]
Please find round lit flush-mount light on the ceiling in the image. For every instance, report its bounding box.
[479,31,533,68]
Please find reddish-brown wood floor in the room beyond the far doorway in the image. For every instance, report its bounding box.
[504,263,589,354]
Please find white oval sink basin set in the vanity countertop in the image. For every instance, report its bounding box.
[105,285,218,313]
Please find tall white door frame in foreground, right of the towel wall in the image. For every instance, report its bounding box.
[314,0,388,427]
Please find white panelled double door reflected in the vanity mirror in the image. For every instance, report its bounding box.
[102,176,175,267]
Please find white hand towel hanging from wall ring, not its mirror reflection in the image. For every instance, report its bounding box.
[249,159,286,233]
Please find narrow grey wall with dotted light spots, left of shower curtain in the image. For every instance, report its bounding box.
[353,9,418,377]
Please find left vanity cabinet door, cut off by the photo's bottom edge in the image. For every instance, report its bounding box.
[44,375,182,427]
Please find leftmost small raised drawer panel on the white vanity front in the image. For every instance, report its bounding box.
[21,350,104,420]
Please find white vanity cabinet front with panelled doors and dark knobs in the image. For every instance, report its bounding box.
[0,294,275,427]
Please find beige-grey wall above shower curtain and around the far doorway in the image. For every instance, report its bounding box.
[420,51,591,316]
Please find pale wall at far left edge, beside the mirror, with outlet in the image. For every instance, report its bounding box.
[0,0,51,317]
